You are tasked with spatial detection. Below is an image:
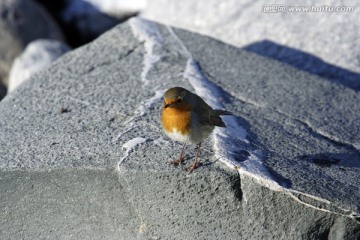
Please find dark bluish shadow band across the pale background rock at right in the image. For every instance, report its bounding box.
[244,40,360,91]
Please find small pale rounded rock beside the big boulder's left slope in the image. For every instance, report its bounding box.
[8,39,70,92]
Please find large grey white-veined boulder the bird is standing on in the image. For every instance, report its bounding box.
[0,19,360,239]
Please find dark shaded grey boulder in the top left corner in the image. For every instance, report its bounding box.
[0,0,64,86]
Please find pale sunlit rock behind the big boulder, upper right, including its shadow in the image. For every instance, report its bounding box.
[141,0,360,90]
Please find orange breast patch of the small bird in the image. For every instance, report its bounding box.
[161,108,190,134]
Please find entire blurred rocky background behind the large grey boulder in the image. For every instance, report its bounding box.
[0,0,360,99]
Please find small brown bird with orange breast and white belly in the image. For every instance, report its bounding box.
[161,87,232,173]
